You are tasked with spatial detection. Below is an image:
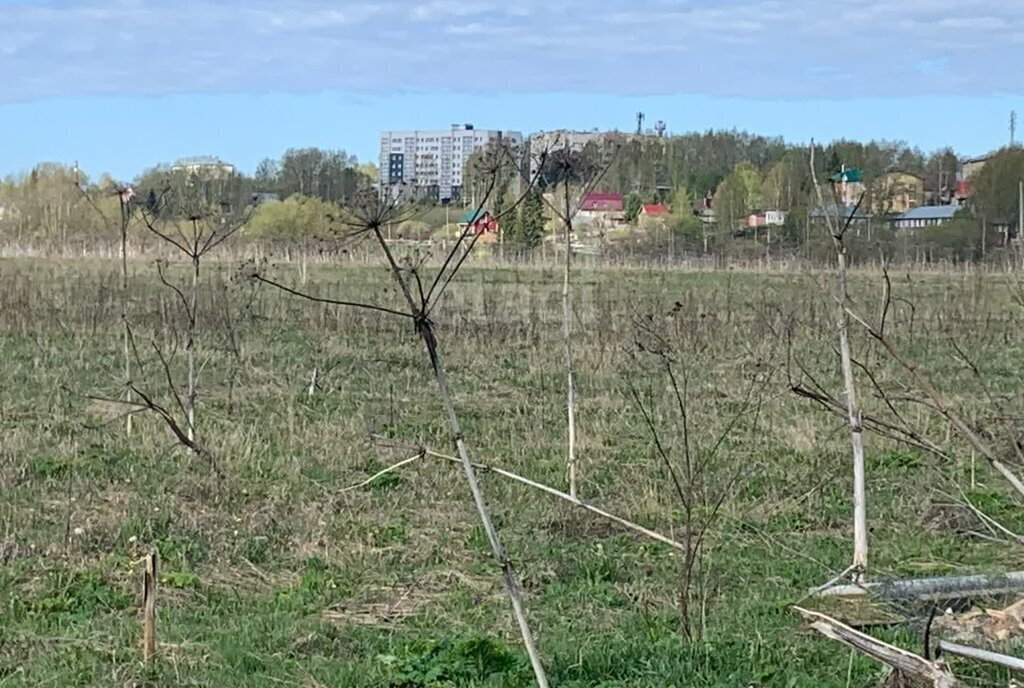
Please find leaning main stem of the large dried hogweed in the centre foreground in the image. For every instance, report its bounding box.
[373,227,549,688]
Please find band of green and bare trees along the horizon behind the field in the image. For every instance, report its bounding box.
[0,131,1024,264]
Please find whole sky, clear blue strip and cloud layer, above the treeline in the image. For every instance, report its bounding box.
[0,0,1024,178]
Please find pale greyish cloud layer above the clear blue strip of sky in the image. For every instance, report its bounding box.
[6,0,1024,102]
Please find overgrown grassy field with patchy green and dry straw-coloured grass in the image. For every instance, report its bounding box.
[0,260,1024,688]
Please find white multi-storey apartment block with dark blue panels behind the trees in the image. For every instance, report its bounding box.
[380,124,522,200]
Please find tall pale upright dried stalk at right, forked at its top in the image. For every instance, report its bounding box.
[811,140,867,581]
